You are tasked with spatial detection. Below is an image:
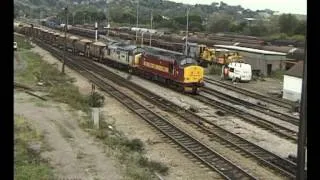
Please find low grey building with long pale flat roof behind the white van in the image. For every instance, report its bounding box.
[215,45,287,76]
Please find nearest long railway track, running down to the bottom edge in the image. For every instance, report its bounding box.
[38,41,257,180]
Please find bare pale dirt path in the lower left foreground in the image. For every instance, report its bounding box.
[14,92,121,180]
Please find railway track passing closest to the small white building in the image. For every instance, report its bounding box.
[205,77,293,109]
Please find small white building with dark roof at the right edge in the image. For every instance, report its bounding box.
[282,61,303,101]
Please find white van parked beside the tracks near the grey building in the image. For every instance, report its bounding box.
[222,62,252,82]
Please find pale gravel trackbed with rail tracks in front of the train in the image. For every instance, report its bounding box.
[14,22,306,179]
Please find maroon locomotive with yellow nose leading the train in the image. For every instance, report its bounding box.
[137,48,204,93]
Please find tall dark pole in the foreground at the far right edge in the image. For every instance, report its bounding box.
[296,35,307,180]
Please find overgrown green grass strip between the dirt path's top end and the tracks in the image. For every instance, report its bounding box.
[15,51,89,112]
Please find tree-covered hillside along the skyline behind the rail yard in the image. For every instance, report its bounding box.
[14,0,305,39]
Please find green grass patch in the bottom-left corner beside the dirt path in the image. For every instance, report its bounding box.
[14,115,53,180]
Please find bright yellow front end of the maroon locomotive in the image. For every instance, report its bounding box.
[183,66,204,83]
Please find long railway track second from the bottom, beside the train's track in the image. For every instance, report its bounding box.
[34,39,296,178]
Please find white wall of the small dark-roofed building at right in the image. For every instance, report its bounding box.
[282,75,302,101]
